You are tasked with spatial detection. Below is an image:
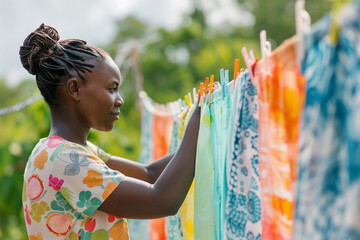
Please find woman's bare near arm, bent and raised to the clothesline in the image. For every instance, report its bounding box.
[99,107,200,219]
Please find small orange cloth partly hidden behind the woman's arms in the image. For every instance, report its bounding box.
[150,115,174,240]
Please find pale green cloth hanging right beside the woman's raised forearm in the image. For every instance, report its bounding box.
[194,104,216,240]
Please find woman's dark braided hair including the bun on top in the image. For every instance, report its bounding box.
[19,24,108,107]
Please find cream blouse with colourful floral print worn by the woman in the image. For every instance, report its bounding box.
[22,136,129,240]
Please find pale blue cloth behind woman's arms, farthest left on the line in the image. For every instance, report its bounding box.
[128,98,153,240]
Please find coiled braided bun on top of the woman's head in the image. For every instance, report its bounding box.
[19,24,60,75]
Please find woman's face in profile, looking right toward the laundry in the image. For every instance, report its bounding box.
[76,56,124,131]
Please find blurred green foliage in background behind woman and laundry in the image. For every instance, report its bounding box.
[0,0,331,240]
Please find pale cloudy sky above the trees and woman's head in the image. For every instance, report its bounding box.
[0,0,253,86]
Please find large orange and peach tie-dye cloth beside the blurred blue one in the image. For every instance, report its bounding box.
[255,38,306,240]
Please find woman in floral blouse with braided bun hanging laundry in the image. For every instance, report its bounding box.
[20,24,200,239]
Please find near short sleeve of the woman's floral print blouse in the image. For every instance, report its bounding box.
[49,144,124,219]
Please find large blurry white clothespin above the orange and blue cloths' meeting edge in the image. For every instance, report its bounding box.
[295,0,311,68]
